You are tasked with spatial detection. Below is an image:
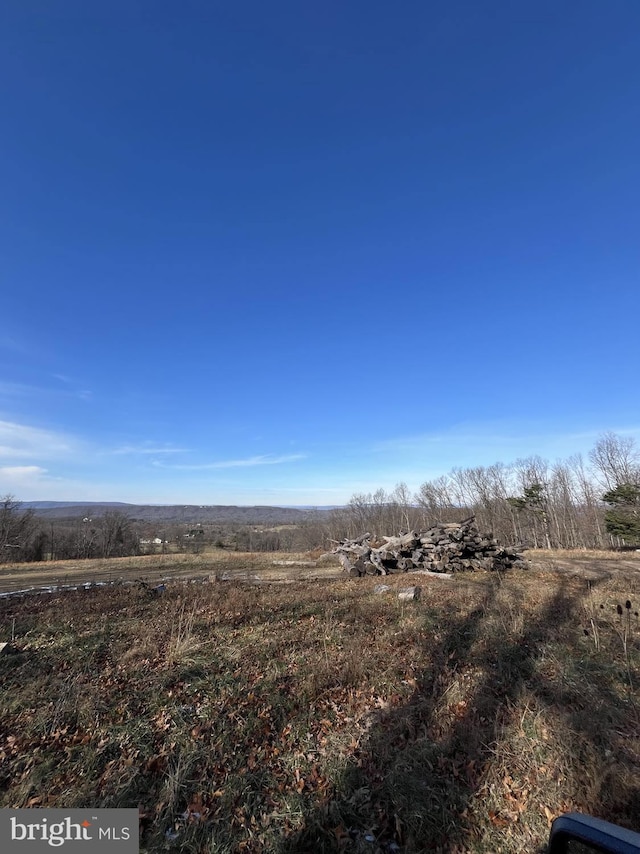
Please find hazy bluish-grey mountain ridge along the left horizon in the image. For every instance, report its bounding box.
[21,501,326,525]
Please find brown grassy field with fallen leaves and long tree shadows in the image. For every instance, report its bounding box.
[0,553,640,854]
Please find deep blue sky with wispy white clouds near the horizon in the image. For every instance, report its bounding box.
[0,0,640,504]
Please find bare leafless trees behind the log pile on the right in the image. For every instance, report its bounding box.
[331,433,640,549]
